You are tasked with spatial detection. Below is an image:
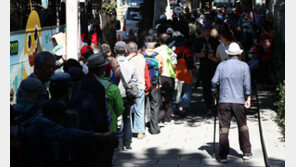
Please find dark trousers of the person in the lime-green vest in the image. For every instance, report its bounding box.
[158,76,175,122]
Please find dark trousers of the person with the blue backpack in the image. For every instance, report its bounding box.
[149,88,161,134]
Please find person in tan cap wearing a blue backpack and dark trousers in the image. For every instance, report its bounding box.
[139,35,163,134]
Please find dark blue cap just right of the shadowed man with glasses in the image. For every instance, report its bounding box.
[50,72,74,88]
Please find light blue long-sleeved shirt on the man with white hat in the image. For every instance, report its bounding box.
[212,57,252,104]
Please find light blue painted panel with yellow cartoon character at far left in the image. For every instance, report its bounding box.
[10,10,65,101]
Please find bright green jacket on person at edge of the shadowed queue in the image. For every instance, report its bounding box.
[100,77,124,132]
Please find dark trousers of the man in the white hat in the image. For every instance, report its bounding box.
[218,103,251,157]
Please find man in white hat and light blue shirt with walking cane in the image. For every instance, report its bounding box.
[212,42,252,163]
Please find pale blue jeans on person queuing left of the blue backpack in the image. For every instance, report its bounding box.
[132,89,145,133]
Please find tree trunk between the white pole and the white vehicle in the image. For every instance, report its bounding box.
[100,0,117,50]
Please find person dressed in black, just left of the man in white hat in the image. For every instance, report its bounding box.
[194,22,219,116]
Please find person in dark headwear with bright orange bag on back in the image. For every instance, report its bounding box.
[174,36,194,116]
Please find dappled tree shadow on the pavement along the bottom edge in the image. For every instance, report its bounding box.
[113,146,285,167]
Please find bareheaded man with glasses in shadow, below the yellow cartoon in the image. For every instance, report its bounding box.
[16,51,56,106]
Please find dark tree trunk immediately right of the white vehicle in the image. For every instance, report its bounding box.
[138,0,155,45]
